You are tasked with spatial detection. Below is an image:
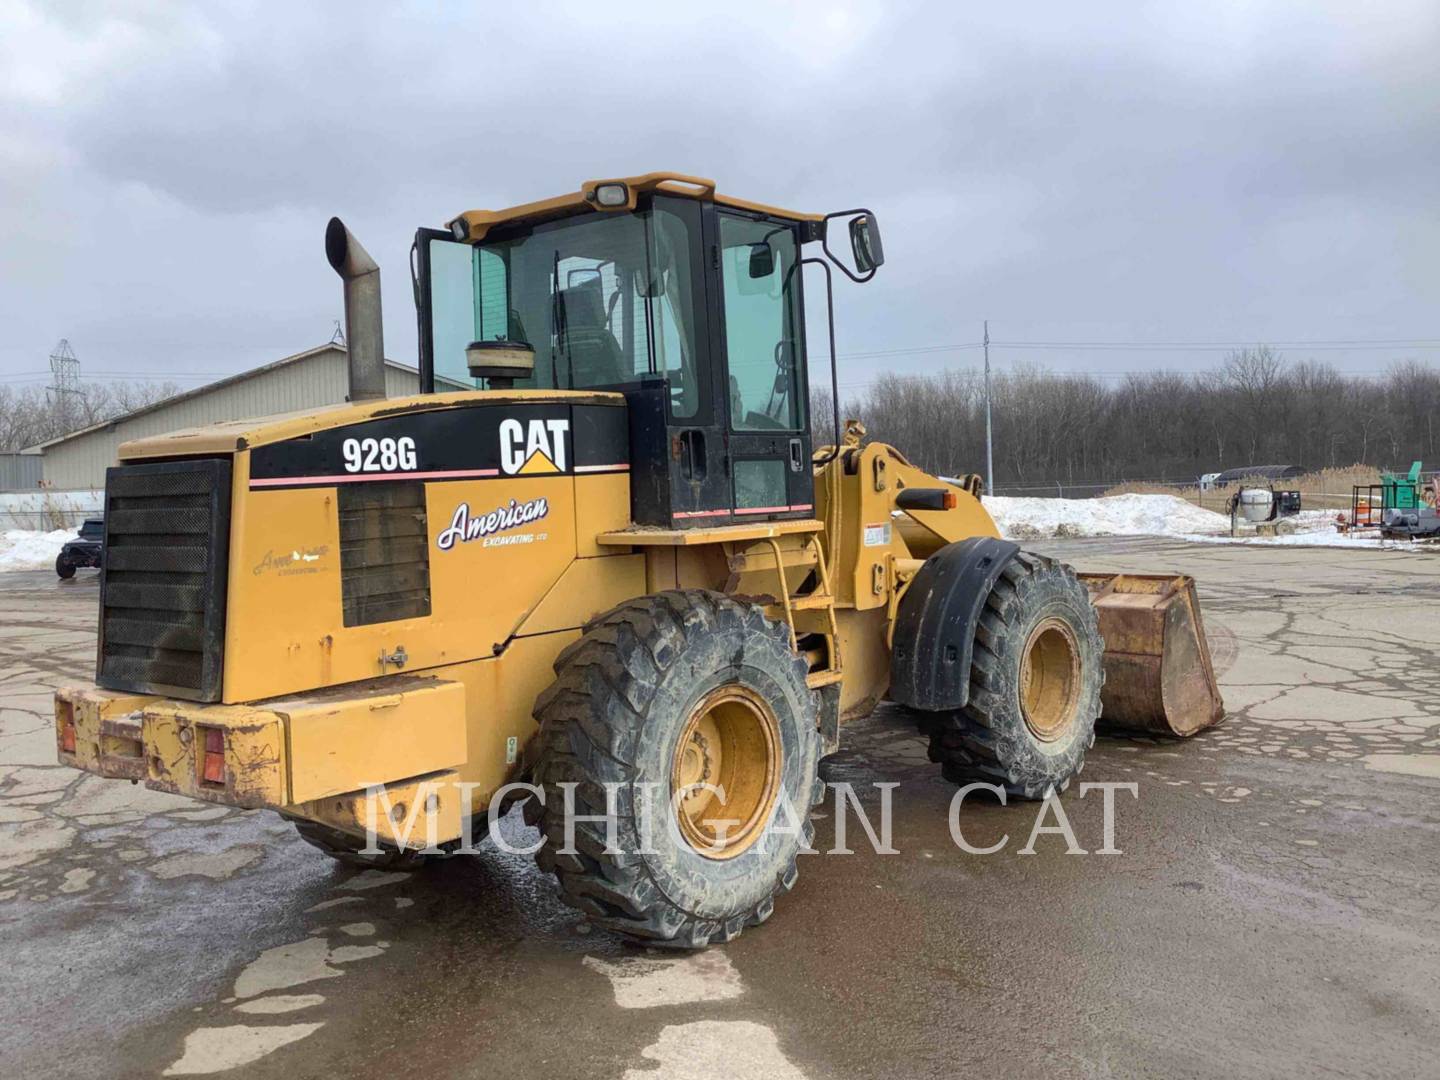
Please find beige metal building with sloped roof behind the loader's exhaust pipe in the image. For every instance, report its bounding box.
[30,344,420,491]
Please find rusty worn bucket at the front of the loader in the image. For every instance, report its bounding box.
[1080,573,1225,736]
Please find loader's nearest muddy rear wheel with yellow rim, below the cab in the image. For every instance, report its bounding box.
[526,589,824,949]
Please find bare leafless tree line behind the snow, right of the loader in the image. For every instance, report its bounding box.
[811,347,1440,491]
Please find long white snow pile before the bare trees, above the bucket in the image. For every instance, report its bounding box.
[985,495,1230,540]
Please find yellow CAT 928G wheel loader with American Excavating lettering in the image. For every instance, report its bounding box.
[56,173,1221,948]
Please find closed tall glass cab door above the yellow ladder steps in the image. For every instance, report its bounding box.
[706,206,815,521]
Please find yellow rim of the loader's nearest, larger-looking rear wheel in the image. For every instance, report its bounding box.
[670,685,780,860]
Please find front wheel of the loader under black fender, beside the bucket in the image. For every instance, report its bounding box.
[919,552,1104,799]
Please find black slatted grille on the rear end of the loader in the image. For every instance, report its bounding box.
[95,458,230,701]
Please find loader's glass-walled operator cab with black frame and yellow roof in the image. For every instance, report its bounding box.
[412,174,878,528]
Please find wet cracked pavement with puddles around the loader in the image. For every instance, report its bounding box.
[0,540,1440,1080]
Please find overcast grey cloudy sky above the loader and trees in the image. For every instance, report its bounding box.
[0,0,1440,403]
